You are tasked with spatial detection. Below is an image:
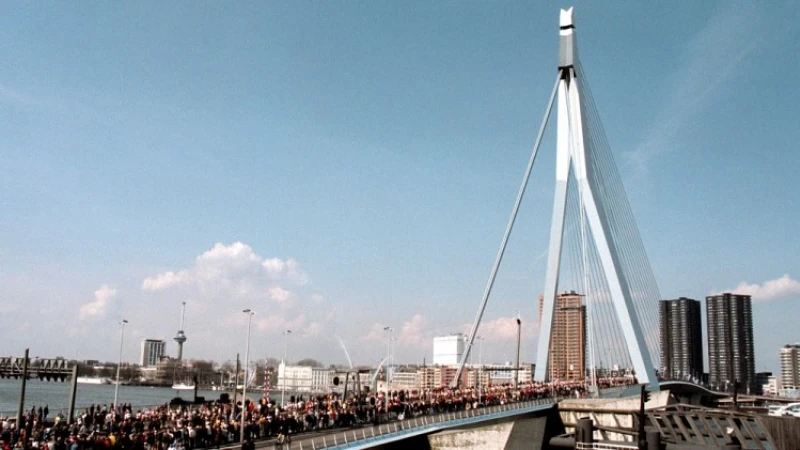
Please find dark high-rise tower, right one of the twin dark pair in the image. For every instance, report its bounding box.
[706,293,756,393]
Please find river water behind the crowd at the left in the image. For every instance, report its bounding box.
[0,379,231,417]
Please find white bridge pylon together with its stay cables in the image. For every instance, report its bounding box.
[452,8,660,391]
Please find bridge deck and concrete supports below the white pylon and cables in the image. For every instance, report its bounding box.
[226,381,800,450]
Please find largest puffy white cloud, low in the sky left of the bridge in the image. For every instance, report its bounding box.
[137,242,324,355]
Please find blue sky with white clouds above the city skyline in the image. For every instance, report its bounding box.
[0,1,800,370]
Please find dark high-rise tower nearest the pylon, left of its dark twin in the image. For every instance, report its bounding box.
[658,297,703,380]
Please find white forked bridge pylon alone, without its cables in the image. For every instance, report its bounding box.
[534,8,658,390]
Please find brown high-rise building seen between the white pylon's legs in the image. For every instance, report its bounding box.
[539,291,586,380]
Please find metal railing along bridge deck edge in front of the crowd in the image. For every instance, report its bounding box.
[304,398,561,450]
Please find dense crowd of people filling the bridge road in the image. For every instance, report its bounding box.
[0,378,631,450]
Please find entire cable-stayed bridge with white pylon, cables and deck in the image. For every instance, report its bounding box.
[278,4,800,450]
